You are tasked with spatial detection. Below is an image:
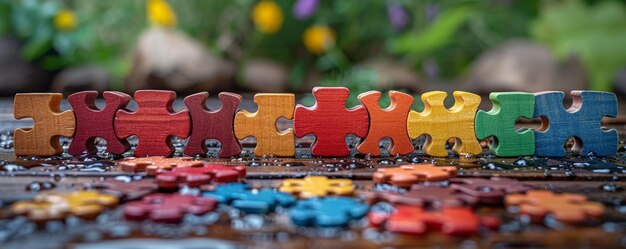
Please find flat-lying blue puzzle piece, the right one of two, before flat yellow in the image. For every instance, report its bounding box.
[289,197,369,227]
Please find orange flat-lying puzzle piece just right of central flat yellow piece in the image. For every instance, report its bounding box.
[372,163,456,188]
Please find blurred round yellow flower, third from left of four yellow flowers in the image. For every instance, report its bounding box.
[252,0,283,34]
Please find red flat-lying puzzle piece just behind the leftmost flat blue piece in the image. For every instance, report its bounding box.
[156,164,246,189]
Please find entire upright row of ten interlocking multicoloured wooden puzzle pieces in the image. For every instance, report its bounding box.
[9,87,618,157]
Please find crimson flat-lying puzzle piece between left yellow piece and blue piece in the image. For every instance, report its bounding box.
[123,194,217,223]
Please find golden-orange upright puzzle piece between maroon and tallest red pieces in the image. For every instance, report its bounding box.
[235,93,296,156]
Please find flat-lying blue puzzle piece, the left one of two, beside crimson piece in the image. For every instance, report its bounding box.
[203,183,296,214]
